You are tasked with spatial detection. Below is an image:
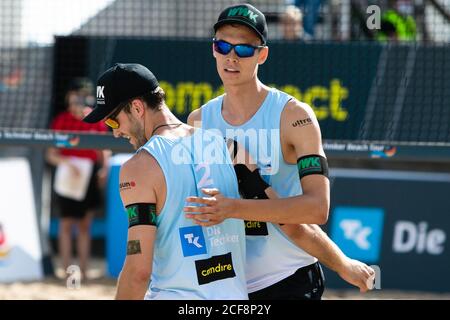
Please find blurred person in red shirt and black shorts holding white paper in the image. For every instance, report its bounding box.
[46,78,109,278]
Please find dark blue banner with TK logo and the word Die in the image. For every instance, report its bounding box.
[326,169,450,292]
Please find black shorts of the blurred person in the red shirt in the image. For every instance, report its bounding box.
[55,165,102,219]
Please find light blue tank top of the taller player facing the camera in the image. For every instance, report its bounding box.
[201,88,317,293]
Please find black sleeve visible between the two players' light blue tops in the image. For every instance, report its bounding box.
[234,163,269,199]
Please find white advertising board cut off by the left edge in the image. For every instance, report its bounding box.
[0,158,43,282]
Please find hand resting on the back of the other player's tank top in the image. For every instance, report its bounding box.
[184,188,234,227]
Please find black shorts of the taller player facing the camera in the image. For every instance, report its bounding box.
[248,262,325,300]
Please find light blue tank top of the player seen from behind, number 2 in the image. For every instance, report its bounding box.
[137,129,248,300]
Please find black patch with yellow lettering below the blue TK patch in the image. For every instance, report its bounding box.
[195,252,236,285]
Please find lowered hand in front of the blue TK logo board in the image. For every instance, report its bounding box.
[338,258,375,292]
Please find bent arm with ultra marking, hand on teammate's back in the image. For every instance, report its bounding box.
[185,100,330,225]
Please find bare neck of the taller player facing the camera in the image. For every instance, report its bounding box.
[222,79,270,126]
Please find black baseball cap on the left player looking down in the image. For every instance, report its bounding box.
[83,63,159,123]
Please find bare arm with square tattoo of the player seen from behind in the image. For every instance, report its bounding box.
[116,152,161,300]
